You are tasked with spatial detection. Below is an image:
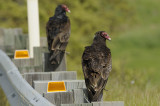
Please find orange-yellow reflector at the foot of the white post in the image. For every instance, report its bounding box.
[14,50,29,59]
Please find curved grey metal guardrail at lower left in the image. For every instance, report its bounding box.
[0,50,54,106]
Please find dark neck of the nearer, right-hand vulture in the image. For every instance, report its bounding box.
[92,36,106,46]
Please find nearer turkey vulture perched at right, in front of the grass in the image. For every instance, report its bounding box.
[82,31,112,102]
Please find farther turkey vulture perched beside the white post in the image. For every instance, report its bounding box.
[46,4,70,64]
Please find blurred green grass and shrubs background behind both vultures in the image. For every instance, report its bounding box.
[0,0,160,106]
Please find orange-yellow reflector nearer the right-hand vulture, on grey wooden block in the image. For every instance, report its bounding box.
[47,81,66,93]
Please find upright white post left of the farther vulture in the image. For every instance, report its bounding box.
[27,0,40,58]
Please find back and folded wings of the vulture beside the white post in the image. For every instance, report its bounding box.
[46,17,70,51]
